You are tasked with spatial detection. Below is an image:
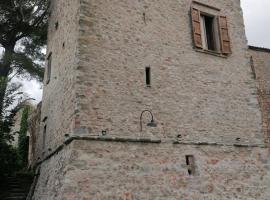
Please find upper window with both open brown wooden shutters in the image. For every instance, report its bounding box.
[191,4,231,55]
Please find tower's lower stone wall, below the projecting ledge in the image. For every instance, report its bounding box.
[34,140,270,200]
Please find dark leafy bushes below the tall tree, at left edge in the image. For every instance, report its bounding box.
[0,77,29,176]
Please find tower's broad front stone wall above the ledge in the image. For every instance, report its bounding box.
[77,0,264,143]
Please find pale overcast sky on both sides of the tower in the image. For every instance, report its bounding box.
[14,0,270,102]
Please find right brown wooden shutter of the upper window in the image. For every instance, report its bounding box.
[219,16,232,54]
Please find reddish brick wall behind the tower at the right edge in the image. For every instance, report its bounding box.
[249,47,270,144]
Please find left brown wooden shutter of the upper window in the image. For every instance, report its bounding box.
[191,8,203,48]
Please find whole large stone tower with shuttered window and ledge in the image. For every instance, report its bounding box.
[33,0,270,200]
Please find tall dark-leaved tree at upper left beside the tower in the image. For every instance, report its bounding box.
[0,0,49,113]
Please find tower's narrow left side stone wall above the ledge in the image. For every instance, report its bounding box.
[40,0,79,157]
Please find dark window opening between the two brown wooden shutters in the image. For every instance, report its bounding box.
[201,15,217,51]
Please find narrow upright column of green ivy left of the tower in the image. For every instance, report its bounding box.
[18,106,30,167]
